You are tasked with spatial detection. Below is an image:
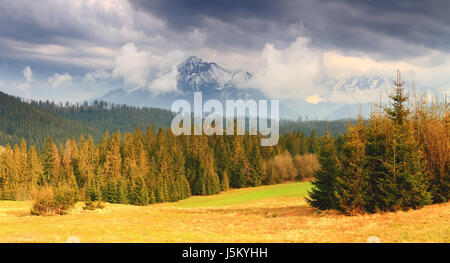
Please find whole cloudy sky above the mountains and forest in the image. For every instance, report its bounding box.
[0,0,450,101]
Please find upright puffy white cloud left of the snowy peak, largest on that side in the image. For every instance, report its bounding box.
[112,43,151,87]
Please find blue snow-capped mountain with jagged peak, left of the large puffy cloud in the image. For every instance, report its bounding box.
[98,56,266,109]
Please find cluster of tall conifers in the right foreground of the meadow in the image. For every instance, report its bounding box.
[308,73,450,215]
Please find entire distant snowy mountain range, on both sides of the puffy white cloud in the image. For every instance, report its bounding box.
[96,56,387,119]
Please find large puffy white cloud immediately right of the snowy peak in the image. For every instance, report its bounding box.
[249,37,322,101]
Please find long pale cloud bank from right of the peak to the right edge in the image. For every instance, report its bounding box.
[246,37,450,104]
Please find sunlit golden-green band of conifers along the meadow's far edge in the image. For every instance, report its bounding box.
[0,126,318,205]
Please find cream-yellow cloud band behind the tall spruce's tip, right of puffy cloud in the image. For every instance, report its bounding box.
[323,50,450,103]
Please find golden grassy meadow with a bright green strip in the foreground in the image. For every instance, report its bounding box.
[0,183,450,242]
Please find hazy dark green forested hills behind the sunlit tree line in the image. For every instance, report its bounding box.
[0,92,348,147]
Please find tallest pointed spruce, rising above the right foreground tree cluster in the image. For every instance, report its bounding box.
[369,72,431,211]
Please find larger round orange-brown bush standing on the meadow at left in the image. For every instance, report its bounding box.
[31,186,76,216]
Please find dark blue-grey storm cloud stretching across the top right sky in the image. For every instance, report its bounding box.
[130,0,450,58]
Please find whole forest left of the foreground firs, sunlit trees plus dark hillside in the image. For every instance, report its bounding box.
[0,89,326,207]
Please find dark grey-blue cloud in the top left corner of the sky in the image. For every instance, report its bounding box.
[0,0,121,44]
